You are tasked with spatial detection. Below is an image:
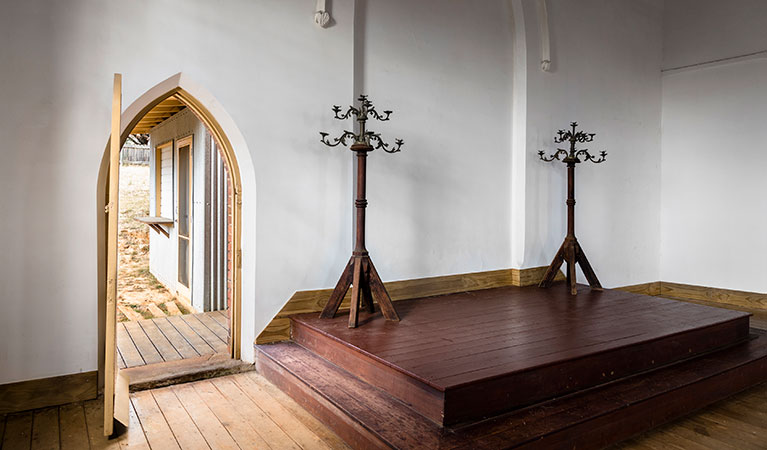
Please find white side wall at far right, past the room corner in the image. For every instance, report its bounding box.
[661,0,767,292]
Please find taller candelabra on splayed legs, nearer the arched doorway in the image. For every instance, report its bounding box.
[320,95,404,328]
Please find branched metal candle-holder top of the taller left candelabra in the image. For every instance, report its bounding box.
[320,94,405,153]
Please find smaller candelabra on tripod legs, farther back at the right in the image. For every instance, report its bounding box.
[538,122,607,295]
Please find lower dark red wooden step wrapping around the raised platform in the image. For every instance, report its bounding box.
[256,330,767,449]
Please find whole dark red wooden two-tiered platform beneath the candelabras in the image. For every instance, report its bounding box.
[257,283,767,448]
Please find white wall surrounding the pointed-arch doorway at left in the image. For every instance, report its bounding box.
[0,0,353,384]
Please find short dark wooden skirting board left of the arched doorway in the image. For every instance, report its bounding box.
[0,370,98,415]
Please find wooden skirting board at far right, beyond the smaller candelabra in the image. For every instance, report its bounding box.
[616,281,767,310]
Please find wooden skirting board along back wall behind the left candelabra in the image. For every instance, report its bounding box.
[256,267,565,344]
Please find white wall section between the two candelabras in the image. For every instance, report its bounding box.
[356,0,512,286]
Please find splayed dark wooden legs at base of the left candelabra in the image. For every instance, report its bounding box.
[320,255,399,328]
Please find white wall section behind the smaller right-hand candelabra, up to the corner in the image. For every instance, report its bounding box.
[512,0,663,287]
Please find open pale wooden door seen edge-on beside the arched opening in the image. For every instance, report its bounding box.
[104,73,129,436]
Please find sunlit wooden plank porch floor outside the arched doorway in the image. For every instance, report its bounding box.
[117,311,229,369]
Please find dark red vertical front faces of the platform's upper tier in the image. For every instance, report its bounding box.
[293,317,749,426]
